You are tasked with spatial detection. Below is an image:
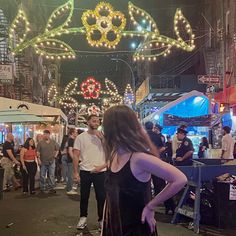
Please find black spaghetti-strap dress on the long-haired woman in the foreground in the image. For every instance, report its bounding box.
[101,154,157,236]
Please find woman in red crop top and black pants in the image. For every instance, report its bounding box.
[20,138,37,195]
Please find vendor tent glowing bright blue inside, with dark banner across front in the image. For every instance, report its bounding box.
[143,90,211,154]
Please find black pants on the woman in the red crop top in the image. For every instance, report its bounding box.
[21,161,37,193]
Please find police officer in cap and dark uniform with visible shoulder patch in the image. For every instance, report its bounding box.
[175,128,194,166]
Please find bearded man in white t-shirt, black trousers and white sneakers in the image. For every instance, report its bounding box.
[73,115,106,229]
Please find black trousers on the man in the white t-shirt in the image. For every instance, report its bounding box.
[80,170,105,221]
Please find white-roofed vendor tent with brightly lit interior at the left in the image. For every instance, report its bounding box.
[0,97,67,144]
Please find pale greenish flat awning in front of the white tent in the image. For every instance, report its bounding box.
[0,110,46,123]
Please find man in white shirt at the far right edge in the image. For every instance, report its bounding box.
[221,126,235,159]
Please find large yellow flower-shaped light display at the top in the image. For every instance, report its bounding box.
[82,2,126,48]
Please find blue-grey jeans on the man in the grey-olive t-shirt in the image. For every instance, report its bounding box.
[40,160,55,191]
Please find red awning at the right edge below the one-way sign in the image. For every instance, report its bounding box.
[214,86,236,105]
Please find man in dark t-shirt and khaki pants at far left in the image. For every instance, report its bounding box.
[1,133,21,191]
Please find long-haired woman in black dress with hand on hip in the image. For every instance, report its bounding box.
[101,105,187,236]
